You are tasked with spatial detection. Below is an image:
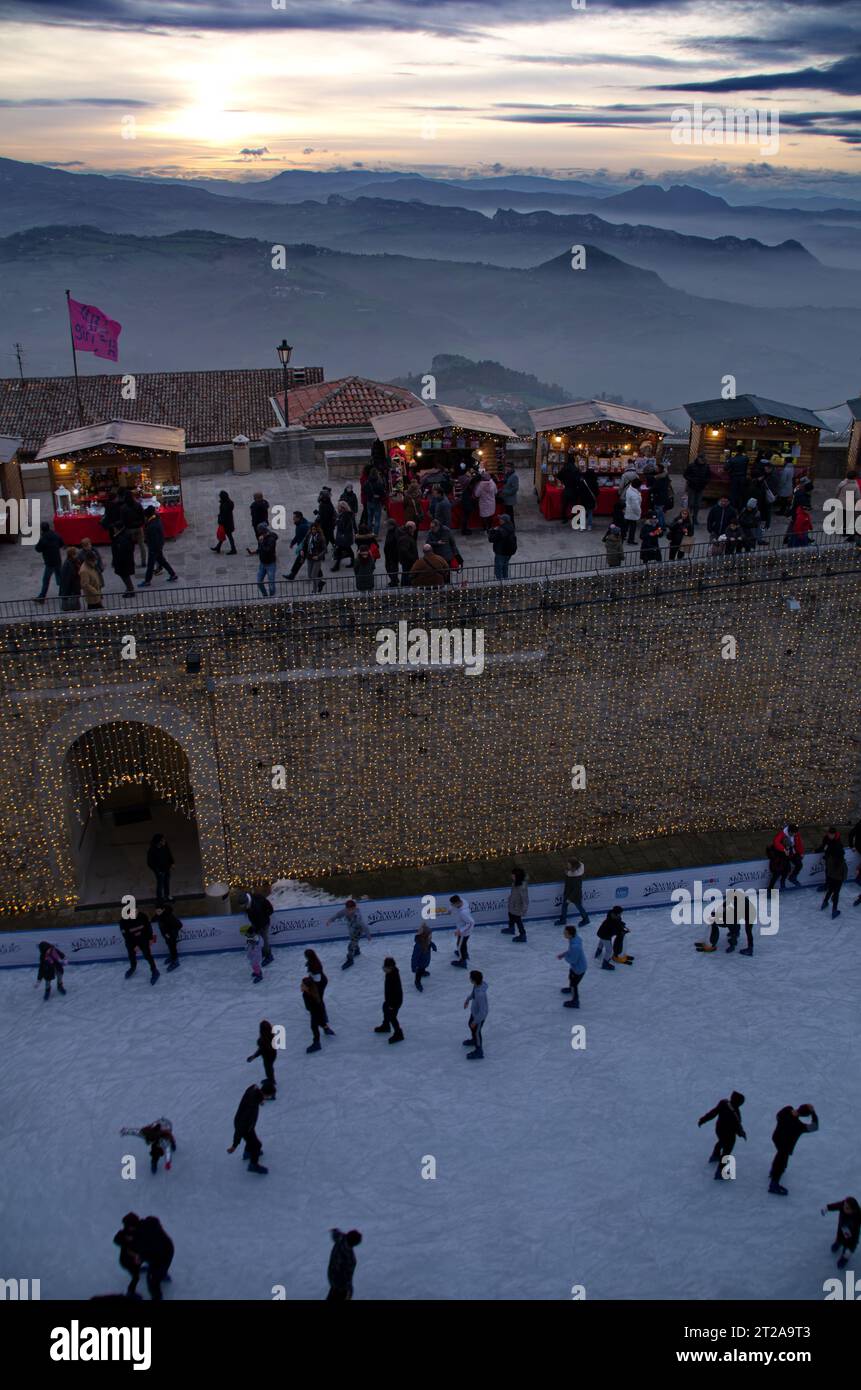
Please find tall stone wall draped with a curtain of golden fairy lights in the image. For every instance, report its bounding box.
[0,546,861,913]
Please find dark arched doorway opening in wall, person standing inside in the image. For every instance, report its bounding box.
[64,719,203,908]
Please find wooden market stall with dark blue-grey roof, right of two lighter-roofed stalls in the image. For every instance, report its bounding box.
[684,396,828,496]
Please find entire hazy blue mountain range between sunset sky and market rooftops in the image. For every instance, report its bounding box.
[0,160,861,410]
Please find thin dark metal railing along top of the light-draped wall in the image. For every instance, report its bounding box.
[0,531,861,623]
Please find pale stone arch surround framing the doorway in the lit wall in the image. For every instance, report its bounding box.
[35,691,225,906]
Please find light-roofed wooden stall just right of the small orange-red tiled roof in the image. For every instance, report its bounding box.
[371,402,517,527]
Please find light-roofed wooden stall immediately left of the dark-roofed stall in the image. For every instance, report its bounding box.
[530,400,669,521]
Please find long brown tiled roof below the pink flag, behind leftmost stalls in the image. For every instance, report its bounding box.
[0,367,323,457]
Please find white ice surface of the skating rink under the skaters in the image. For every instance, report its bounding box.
[0,883,861,1300]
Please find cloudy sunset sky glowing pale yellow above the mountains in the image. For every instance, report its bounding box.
[0,0,861,197]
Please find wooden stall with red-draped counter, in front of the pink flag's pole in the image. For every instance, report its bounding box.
[36,420,188,545]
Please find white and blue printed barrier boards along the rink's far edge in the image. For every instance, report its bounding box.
[0,851,858,969]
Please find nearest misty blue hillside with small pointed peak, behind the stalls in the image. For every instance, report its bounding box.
[0,225,858,411]
